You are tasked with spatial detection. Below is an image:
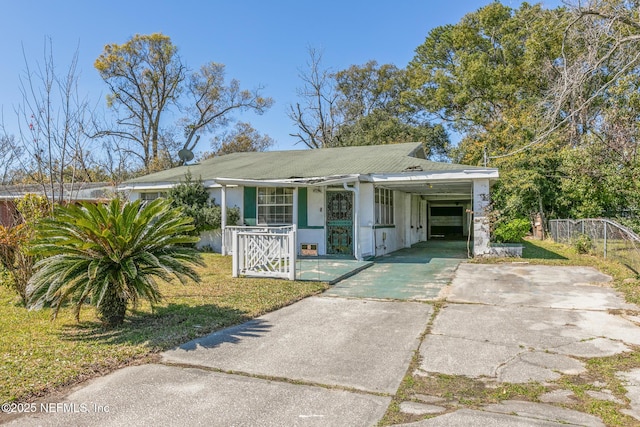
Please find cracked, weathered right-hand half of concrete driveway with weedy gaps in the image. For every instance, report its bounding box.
[411,264,640,427]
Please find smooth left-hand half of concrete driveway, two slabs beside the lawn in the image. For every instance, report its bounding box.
[6,297,433,426]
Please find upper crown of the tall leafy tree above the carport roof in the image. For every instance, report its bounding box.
[405,2,562,148]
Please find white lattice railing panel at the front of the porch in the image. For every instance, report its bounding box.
[231,226,296,280]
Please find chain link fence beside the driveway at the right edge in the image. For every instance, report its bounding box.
[549,218,640,274]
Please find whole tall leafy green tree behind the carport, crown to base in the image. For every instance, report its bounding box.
[404,2,568,221]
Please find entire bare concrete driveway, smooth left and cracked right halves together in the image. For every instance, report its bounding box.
[6,256,640,426]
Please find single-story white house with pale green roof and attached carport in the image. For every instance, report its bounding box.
[119,143,498,260]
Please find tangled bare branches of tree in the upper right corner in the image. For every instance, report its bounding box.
[484,0,640,159]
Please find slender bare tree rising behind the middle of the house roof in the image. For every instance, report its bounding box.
[289,48,342,148]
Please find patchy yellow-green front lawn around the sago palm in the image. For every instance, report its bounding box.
[0,254,326,402]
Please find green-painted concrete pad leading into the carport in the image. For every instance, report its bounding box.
[325,240,467,300]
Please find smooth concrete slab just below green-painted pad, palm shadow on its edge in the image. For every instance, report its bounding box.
[162,297,432,394]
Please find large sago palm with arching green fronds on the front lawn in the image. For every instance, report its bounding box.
[28,199,202,326]
